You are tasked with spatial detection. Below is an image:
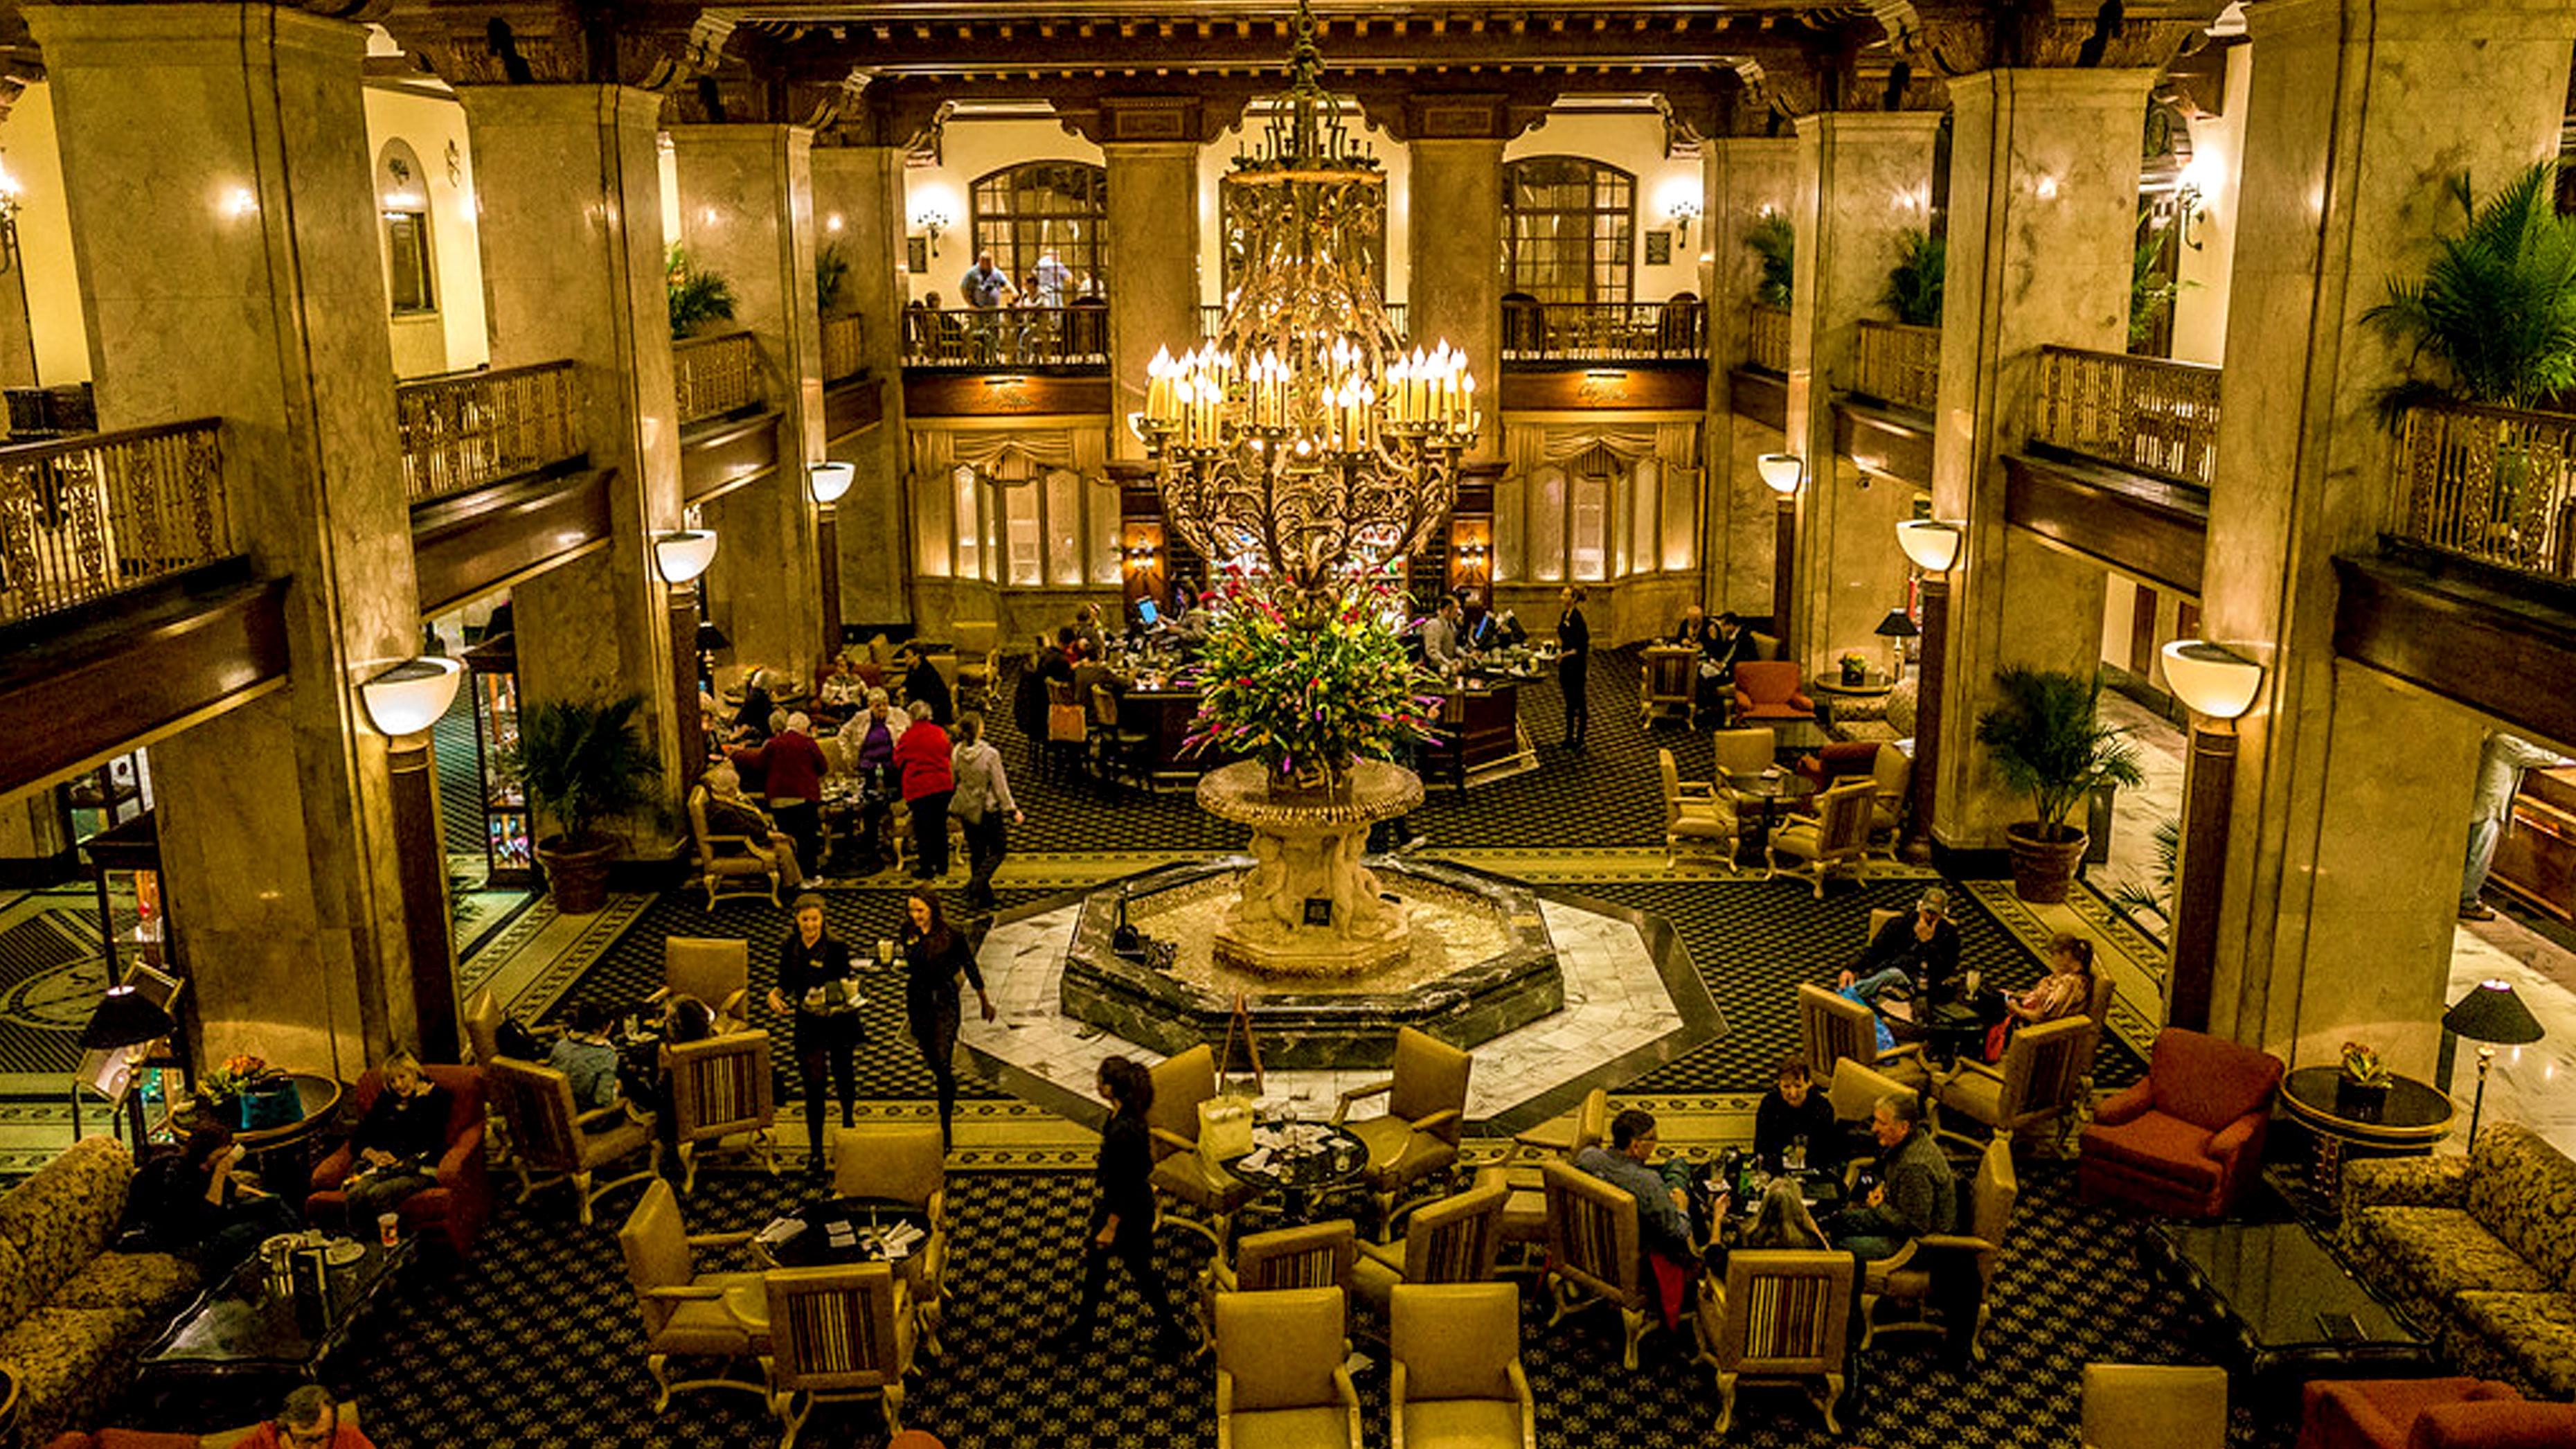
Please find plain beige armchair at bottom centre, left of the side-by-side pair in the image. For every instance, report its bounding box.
[1216,1289,1360,1449]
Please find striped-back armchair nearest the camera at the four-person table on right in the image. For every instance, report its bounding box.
[1692,1248,1852,1436]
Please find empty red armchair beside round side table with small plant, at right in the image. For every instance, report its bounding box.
[2076,1026,2282,1217]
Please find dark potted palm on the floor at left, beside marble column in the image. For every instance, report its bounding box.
[508,693,662,915]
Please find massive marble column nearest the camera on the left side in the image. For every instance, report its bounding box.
[23,5,422,1081]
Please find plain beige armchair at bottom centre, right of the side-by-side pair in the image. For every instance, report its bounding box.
[1386,1284,1538,1449]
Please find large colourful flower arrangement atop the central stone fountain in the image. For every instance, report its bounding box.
[1185,580,1438,781]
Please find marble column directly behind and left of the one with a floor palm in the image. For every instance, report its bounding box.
[1788,111,1940,678]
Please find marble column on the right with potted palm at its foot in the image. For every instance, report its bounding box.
[1937,70,2154,848]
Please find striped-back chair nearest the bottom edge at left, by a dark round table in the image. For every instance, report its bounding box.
[744,1263,912,1449]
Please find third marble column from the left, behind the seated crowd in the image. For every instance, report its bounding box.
[670,126,824,678]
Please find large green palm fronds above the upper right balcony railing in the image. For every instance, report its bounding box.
[2362,160,2576,428]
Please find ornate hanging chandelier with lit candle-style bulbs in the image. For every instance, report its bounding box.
[1128,3,1478,603]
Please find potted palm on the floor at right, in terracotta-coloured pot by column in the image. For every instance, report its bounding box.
[1976,665,2146,905]
